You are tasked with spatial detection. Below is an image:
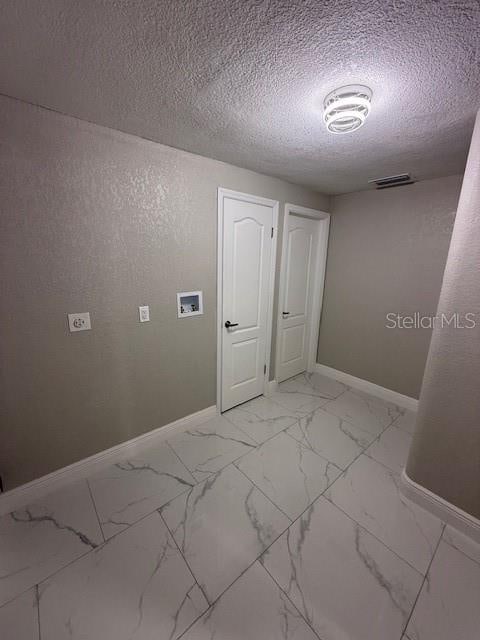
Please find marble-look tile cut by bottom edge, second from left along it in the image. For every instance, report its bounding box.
[38,513,208,640]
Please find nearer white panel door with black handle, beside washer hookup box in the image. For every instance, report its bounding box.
[219,191,278,411]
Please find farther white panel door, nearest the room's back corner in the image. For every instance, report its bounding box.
[277,213,321,382]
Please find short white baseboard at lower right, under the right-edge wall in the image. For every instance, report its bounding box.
[400,469,480,544]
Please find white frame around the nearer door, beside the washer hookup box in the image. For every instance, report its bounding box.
[217,187,279,414]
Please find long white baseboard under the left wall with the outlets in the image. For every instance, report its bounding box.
[0,406,217,515]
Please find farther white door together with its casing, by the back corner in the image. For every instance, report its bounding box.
[276,204,330,382]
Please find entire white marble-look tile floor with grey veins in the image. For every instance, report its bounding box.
[0,374,480,640]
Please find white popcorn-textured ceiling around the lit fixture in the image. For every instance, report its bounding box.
[0,0,480,193]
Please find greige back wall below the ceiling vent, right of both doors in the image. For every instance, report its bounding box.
[317,176,461,398]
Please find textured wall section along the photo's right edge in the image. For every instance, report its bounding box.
[407,112,480,519]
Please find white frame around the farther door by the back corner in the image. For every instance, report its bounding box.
[275,202,330,380]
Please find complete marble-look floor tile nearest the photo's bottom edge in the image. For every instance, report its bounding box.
[161,465,290,602]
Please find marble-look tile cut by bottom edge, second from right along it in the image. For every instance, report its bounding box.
[262,497,422,640]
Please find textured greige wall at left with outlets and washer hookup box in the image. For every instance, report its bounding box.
[0,98,328,488]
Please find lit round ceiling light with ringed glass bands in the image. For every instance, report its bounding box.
[323,84,372,133]
